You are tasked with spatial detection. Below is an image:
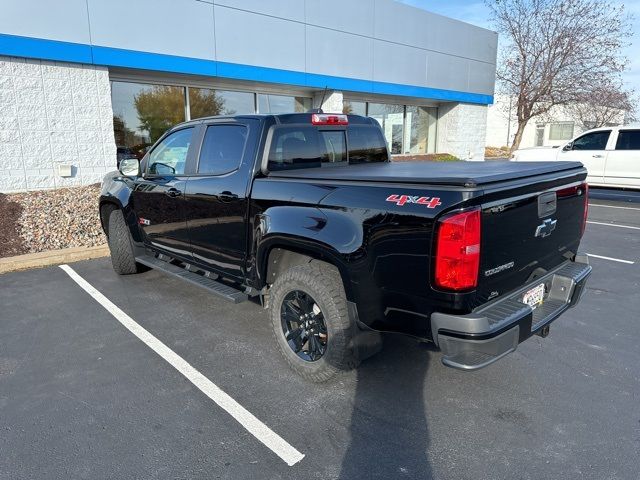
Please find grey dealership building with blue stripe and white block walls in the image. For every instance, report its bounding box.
[0,0,497,192]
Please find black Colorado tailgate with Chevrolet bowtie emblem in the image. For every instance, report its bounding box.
[476,169,587,305]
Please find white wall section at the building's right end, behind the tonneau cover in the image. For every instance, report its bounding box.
[436,103,487,160]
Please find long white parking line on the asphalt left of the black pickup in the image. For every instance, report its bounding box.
[60,265,304,466]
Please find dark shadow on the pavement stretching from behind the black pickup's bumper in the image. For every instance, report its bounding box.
[339,334,435,480]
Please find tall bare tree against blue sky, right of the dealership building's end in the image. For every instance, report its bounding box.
[486,0,631,150]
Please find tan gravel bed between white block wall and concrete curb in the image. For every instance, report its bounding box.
[0,184,106,256]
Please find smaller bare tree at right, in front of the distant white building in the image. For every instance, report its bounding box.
[566,80,635,130]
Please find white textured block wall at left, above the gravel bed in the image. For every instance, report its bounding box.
[0,57,116,193]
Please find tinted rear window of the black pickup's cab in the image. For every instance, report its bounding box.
[268,125,388,171]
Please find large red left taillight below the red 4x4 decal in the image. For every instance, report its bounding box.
[435,209,480,290]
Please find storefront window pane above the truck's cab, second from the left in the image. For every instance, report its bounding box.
[189,87,255,119]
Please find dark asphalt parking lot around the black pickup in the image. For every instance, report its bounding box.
[0,189,640,480]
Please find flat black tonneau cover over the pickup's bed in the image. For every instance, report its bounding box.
[269,161,582,187]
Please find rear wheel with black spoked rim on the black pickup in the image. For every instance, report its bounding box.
[270,260,357,382]
